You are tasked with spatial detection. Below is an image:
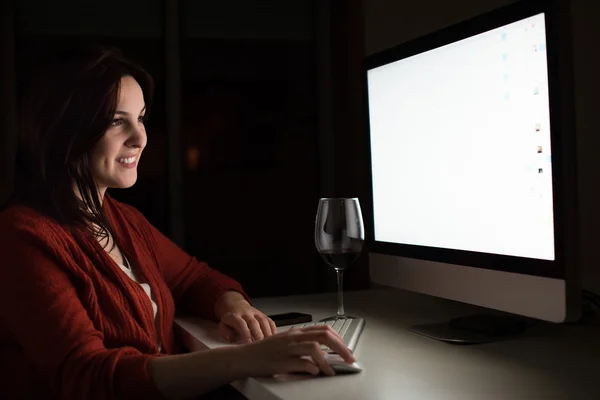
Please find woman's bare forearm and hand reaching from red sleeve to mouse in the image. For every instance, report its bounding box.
[148,325,354,399]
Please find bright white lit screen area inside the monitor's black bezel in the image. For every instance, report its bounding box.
[367,14,554,260]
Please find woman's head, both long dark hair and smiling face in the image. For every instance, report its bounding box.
[15,47,154,242]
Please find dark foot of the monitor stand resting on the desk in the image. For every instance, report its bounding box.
[408,314,531,344]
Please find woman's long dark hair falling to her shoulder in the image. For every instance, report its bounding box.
[13,47,154,245]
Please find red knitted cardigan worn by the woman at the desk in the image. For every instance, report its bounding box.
[0,195,247,400]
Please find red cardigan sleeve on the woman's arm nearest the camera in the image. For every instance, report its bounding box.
[0,226,162,399]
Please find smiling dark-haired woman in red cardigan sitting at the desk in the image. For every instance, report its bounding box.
[0,45,353,399]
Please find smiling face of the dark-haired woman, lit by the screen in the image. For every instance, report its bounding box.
[91,76,146,198]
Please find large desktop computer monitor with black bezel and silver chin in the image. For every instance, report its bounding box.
[365,1,581,340]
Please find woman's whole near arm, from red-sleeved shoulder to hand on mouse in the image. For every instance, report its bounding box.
[0,219,353,400]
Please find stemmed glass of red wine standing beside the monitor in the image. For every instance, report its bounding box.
[315,197,365,321]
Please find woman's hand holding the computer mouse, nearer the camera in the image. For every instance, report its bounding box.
[238,325,356,376]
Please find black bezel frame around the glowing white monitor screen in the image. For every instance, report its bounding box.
[363,0,577,280]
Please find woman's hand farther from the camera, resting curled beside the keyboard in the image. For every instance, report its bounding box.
[215,292,277,343]
